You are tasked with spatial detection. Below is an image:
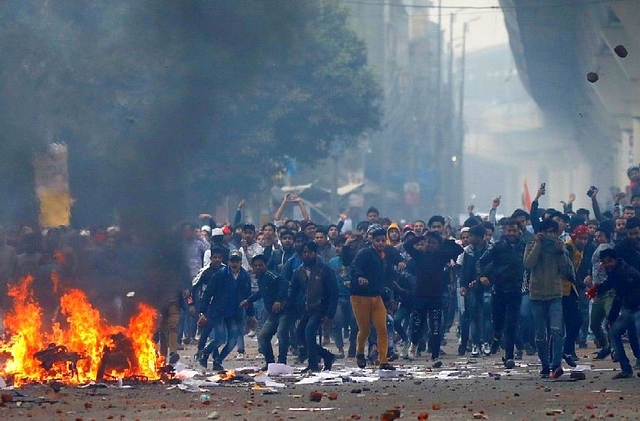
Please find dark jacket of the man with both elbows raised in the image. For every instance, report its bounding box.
[404,237,464,297]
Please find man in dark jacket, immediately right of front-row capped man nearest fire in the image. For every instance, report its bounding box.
[240,254,290,371]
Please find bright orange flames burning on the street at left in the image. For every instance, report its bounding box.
[0,277,163,386]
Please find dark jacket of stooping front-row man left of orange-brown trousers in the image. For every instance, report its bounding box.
[287,260,338,319]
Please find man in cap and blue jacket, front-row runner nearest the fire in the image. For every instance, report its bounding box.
[197,250,251,370]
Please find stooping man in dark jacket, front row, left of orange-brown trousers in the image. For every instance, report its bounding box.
[288,241,338,372]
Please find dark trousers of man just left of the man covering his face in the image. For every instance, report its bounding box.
[491,291,522,360]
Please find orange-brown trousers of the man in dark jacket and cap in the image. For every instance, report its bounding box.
[351,295,389,364]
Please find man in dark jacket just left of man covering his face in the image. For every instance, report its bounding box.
[478,219,526,368]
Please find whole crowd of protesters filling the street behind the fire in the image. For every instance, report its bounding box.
[0,168,640,379]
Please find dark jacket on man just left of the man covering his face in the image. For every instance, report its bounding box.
[477,236,526,292]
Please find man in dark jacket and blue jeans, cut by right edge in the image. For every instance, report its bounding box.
[598,249,640,380]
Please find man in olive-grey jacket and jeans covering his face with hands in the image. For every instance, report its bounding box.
[524,219,575,379]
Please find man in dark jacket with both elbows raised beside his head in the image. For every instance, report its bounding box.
[404,231,464,368]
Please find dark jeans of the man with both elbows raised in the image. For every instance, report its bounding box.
[411,297,443,359]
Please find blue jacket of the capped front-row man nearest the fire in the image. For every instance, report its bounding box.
[199,266,251,319]
